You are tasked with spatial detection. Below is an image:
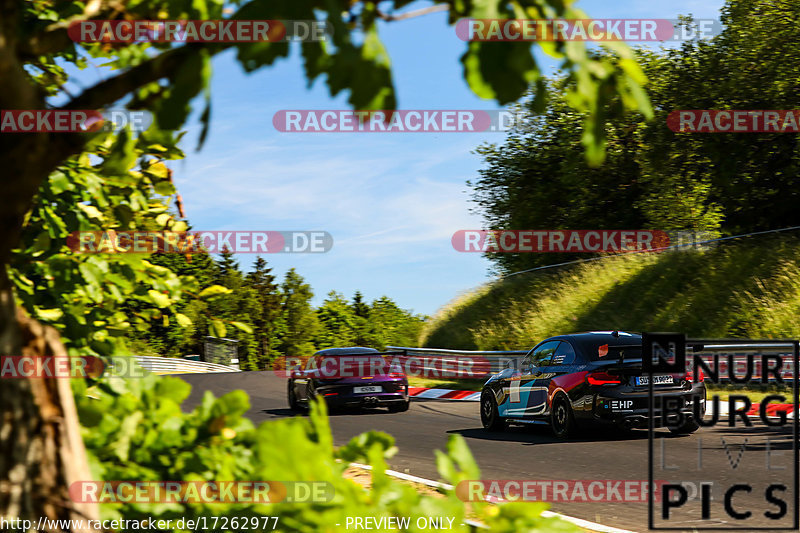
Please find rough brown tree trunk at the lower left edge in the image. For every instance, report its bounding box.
[0,267,98,533]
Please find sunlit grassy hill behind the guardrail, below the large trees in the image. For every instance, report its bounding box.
[421,235,800,350]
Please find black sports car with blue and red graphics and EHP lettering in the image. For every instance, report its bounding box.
[481,331,706,438]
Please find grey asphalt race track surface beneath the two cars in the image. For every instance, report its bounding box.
[180,372,795,531]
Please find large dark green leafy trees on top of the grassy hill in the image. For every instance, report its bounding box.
[474,0,800,273]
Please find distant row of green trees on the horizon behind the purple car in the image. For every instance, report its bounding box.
[119,247,424,364]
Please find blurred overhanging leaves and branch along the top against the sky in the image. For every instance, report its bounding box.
[20,0,652,164]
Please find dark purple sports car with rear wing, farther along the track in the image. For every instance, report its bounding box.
[287,346,409,412]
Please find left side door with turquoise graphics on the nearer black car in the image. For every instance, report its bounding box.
[500,341,560,418]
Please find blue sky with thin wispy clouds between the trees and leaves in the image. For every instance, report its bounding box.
[94,0,722,314]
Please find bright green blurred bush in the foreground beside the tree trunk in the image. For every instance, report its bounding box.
[76,375,580,533]
